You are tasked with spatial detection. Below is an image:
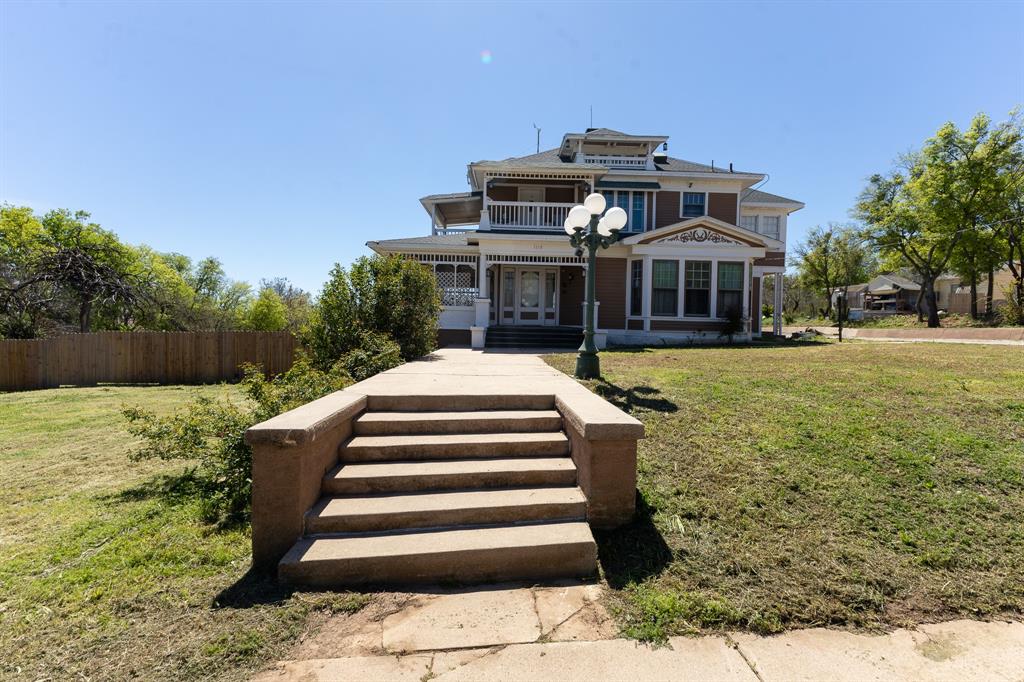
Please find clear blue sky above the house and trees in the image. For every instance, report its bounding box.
[0,0,1024,291]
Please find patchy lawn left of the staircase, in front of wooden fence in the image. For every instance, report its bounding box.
[0,386,366,680]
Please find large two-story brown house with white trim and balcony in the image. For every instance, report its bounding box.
[368,128,804,347]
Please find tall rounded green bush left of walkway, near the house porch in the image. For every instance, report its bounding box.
[301,256,440,370]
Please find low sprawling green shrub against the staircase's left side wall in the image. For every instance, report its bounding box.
[122,358,352,524]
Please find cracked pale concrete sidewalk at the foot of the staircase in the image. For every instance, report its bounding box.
[249,583,1024,682]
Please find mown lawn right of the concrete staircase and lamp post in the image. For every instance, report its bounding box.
[547,343,1024,640]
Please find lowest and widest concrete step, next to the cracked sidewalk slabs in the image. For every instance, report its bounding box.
[278,521,597,586]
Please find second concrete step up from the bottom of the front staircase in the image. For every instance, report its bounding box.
[306,486,587,535]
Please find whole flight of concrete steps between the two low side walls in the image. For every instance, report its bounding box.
[278,395,597,586]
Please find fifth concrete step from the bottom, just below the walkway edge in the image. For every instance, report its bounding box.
[353,410,562,435]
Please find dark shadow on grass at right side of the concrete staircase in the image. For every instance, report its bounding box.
[594,492,672,590]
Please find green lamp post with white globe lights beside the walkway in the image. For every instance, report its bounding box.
[565,193,627,379]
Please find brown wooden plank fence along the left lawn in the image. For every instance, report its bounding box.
[0,332,298,391]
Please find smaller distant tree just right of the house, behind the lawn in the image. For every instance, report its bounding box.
[794,223,876,317]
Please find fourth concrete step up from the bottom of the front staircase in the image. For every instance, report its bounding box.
[341,432,569,462]
